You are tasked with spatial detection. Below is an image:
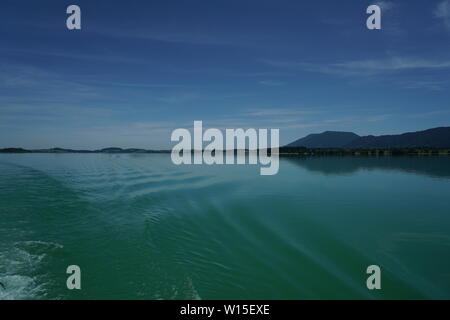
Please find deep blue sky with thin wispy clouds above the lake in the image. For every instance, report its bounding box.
[0,0,450,149]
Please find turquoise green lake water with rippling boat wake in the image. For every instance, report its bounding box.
[0,154,450,299]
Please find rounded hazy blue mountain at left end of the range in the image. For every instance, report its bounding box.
[286,131,360,148]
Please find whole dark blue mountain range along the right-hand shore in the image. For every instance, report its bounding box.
[286,127,450,149]
